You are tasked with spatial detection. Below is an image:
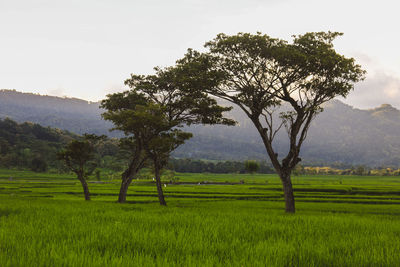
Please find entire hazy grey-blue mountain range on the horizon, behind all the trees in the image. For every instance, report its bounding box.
[0,90,400,167]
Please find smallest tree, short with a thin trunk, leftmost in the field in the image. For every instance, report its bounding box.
[57,135,105,200]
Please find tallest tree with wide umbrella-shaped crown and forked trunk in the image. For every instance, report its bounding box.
[177,32,365,212]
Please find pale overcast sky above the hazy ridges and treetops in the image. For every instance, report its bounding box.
[0,0,400,109]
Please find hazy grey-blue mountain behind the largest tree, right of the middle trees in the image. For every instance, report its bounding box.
[176,100,400,166]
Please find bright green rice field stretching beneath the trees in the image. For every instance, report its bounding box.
[0,170,400,266]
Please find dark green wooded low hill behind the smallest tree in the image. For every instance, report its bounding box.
[0,118,125,172]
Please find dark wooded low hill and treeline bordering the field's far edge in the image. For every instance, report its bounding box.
[0,118,400,177]
